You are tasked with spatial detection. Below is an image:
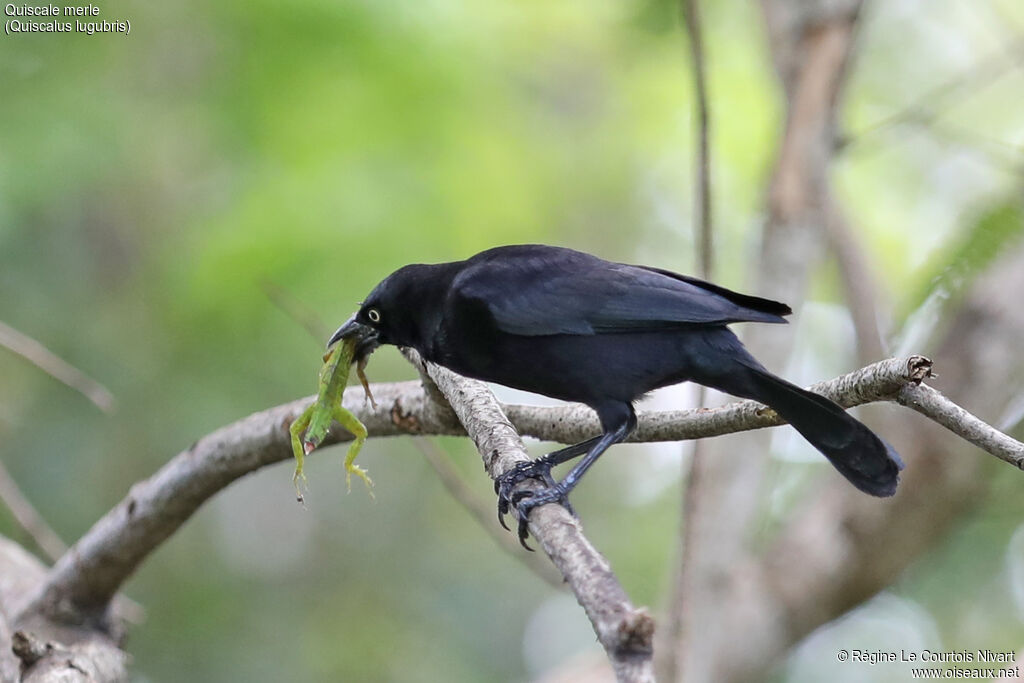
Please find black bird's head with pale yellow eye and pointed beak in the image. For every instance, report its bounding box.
[328,264,440,352]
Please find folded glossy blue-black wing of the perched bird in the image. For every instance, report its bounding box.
[452,249,791,337]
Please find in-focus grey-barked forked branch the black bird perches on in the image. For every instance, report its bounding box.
[4,339,1024,681]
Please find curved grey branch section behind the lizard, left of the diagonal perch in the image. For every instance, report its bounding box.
[14,382,461,623]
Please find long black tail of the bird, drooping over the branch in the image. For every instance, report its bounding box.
[715,357,903,497]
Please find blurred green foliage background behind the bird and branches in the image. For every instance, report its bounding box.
[0,0,1024,682]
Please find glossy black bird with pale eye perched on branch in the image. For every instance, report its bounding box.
[329,245,903,545]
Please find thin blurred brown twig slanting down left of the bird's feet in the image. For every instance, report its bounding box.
[413,437,565,590]
